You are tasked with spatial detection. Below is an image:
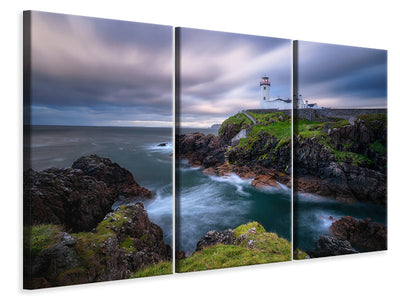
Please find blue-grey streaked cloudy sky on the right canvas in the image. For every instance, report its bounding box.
[298,41,387,108]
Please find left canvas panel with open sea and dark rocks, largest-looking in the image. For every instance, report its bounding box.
[24,11,173,289]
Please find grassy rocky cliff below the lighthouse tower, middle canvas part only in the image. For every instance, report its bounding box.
[176,112,291,186]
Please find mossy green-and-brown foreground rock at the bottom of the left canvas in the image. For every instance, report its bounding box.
[25,202,171,288]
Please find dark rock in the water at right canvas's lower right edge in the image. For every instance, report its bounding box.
[329,216,387,251]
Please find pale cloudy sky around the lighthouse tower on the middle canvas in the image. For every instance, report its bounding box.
[179,28,292,127]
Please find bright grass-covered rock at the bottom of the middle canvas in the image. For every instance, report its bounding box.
[176,222,291,272]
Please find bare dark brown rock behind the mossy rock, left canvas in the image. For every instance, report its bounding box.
[24,155,151,232]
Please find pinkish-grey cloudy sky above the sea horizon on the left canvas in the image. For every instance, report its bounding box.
[27,12,173,127]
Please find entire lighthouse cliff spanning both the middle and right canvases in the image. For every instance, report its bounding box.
[176,110,387,205]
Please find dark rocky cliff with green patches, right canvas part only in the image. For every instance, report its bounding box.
[293,114,387,204]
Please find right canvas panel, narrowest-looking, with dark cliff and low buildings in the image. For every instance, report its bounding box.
[293,41,387,259]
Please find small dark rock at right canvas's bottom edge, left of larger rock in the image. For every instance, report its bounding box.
[307,235,358,258]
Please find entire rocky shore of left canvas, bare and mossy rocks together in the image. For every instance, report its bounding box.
[24,155,171,289]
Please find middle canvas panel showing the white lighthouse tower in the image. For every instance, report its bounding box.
[175,28,292,272]
